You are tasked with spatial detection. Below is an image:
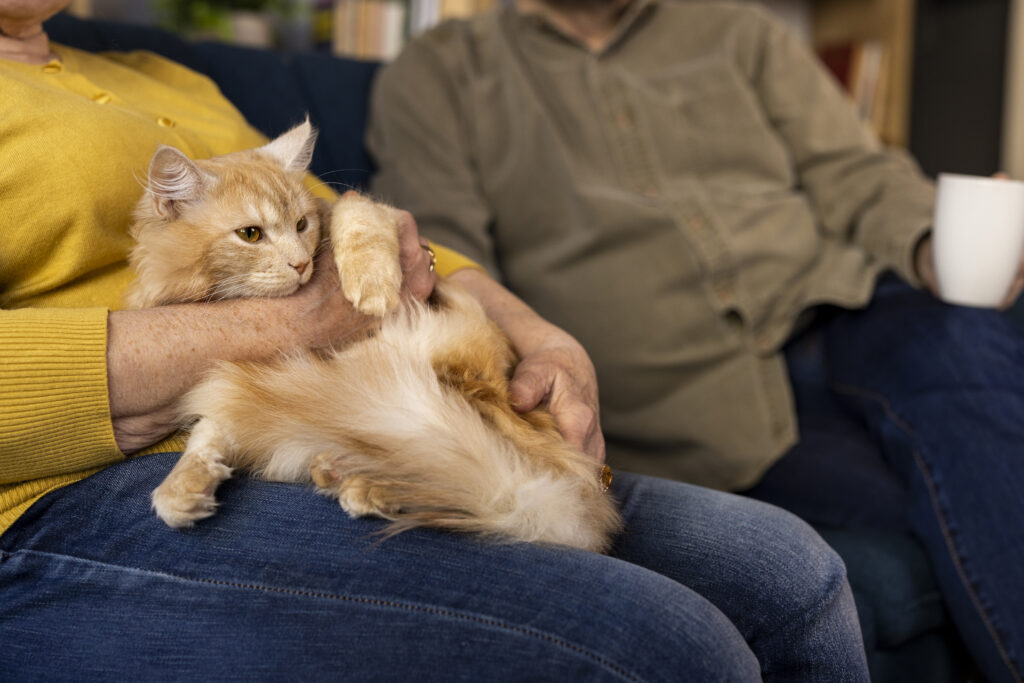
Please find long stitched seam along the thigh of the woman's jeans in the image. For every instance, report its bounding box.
[0,549,643,683]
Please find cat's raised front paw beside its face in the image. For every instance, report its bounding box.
[330,194,401,316]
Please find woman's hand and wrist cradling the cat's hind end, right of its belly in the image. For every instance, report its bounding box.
[449,268,604,463]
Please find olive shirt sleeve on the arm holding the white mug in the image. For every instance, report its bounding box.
[746,6,935,285]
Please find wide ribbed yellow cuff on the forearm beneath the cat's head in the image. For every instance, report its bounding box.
[0,308,123,483]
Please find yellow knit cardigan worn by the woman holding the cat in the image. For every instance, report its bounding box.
[0,45,471,533]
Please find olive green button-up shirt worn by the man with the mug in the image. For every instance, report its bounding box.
[369,0,934,489]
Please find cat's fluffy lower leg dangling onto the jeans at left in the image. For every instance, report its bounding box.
[153,418,231,526]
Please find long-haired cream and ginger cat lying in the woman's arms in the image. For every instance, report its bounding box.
[125,120,621,552]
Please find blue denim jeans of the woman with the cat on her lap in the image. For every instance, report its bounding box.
[0,454,867,683]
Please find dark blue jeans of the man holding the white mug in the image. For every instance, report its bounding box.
[762,276,1024,683]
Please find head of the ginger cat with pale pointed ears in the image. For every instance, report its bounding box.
[126,120,321,307]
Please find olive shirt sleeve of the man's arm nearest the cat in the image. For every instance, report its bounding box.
[367,31,499,276]
